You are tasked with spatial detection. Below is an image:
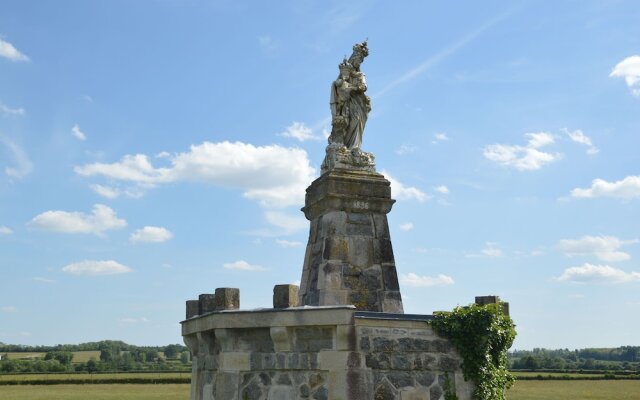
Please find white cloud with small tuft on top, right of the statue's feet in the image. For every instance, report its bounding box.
[483,132,562,171]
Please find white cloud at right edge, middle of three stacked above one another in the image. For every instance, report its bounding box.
[558,236,639,262]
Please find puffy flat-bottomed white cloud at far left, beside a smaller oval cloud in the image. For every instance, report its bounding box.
[29,204,127,235]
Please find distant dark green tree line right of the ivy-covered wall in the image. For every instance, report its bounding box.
[509,346,640,371]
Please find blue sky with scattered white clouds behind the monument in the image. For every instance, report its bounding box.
[0,0,640,349]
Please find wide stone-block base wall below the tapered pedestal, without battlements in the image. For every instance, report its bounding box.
[182,306,473,400]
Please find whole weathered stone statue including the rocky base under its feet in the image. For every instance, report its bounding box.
[322,40,375,173]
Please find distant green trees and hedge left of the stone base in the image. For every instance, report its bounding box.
[0,340,191,373]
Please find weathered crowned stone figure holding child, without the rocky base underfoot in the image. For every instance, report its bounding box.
[329,41,371,152]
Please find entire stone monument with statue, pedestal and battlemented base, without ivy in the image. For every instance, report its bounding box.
[182,42,498,400]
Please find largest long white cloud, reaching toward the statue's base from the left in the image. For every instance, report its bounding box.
[74,141,315,208]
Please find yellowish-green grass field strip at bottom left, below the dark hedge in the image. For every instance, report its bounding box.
[0,384,189,400]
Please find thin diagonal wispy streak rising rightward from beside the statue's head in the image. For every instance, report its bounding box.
[373,12,510,97]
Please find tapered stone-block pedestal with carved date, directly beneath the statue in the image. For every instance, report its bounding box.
[300,168,403,313]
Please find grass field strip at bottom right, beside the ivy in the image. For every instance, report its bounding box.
[510,381,640,400]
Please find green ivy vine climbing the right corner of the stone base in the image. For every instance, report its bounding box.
[431,303,516,400]
